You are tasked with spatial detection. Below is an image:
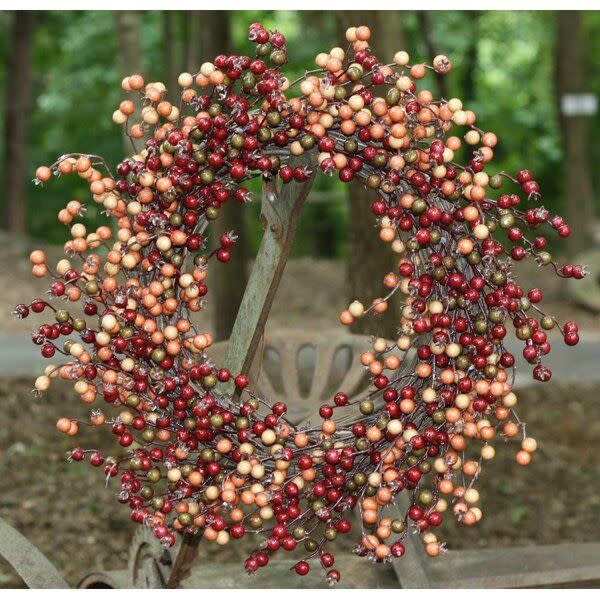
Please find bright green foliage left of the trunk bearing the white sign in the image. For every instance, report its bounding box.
[474,12,562,210]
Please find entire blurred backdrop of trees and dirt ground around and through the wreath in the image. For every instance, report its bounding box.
[0,10,600,588]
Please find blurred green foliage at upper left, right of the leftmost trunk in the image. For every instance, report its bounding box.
[21,11,161,243]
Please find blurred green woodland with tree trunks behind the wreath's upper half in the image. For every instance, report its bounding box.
[0,11,600,337]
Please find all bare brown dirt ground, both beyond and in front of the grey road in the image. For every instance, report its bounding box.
[0,235,600,588]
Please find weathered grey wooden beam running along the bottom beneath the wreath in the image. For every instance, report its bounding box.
[178,540,600,589]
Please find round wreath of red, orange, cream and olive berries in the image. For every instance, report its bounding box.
[16,23,585,583]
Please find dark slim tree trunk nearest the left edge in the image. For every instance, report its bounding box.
[4,11,35,233]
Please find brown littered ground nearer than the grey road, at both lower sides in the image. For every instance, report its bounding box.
[0,378,600,587]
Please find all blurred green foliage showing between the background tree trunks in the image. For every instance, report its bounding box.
[0,10,600,256]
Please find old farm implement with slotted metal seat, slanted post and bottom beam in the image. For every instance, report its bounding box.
[0,155,600,588]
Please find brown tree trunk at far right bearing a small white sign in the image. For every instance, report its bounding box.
[556,11,594,259]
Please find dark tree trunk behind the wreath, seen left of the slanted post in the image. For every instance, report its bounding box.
[186,10,248,340]
